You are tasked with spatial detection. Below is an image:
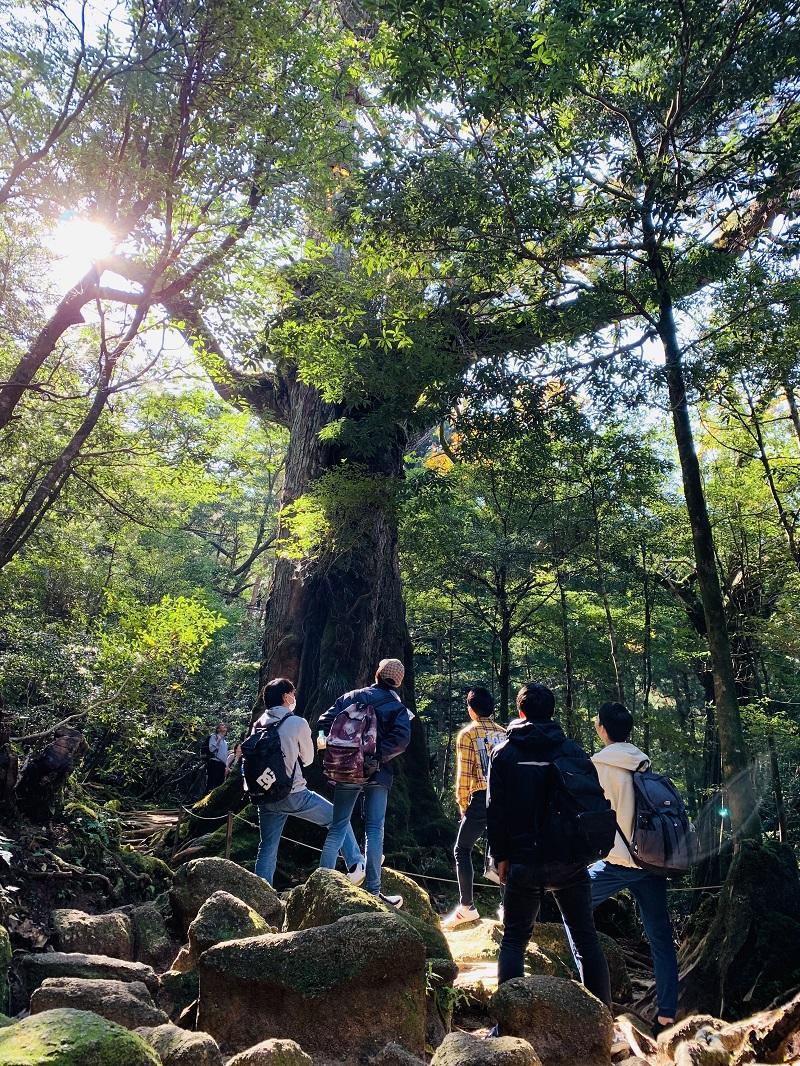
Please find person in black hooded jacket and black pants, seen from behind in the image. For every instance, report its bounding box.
[486,682,611,1008]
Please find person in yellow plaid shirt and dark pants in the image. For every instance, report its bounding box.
[443,685,506,928]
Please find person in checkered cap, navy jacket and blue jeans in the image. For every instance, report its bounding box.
[317,659,411,907]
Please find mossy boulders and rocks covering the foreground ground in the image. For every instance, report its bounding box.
[0,857,800,1066]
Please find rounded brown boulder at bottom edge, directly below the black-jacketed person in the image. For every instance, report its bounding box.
[490,978,613,1066]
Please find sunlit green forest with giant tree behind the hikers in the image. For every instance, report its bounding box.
[0,0,800,1036]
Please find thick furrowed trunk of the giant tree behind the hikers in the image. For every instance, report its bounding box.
[259,382,447,843]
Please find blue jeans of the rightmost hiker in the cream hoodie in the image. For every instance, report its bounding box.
[589,860,677,1018]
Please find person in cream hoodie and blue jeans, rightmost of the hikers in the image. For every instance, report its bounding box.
[589,704,677,1031]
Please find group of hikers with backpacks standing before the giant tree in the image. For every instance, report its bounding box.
[204,659,681,1030]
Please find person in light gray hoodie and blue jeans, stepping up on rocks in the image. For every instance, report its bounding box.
[253,677,366,885]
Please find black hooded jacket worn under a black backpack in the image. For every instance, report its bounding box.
[486,718,589,887]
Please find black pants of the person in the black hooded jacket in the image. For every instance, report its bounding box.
[497,863,611,1010]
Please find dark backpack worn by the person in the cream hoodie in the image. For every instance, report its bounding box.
[617,763,699,877]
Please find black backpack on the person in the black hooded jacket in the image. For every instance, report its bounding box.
[538,753,617,866]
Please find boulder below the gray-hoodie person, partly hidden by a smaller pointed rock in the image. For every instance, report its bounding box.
[170,858,284,933]
